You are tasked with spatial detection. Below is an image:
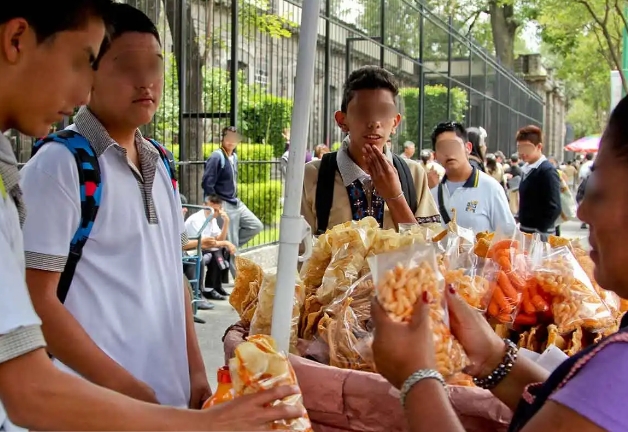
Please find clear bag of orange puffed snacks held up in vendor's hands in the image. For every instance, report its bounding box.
[369,245,468,378]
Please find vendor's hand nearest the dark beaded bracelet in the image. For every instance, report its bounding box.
[445,285,505,377]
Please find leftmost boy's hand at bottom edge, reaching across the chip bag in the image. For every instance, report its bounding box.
[199,386,305,431]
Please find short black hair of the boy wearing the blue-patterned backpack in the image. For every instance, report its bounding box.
[95,3,161,67]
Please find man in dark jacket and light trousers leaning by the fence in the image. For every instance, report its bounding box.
[203,126,264,249]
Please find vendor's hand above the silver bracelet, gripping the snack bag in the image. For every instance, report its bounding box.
[371,293,436,388]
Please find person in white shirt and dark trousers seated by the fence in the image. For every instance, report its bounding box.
[185,195,236,300]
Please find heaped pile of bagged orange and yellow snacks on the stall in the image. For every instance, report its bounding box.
[230,218,628,385]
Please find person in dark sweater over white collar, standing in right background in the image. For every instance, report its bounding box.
[517,126,561,239]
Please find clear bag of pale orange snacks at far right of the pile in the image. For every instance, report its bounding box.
[534,247,615,333]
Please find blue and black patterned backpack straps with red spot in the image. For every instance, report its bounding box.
[31,129,177,303]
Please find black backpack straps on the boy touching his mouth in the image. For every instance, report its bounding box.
[316,152,418,235]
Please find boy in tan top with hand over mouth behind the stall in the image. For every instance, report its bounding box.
[301,66,440,234]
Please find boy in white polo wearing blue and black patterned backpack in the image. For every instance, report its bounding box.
[22,0,204,408]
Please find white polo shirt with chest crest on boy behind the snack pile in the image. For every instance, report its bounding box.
[431,168,515,233]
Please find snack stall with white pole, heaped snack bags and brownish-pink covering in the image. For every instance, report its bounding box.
[223,0,625,432]
